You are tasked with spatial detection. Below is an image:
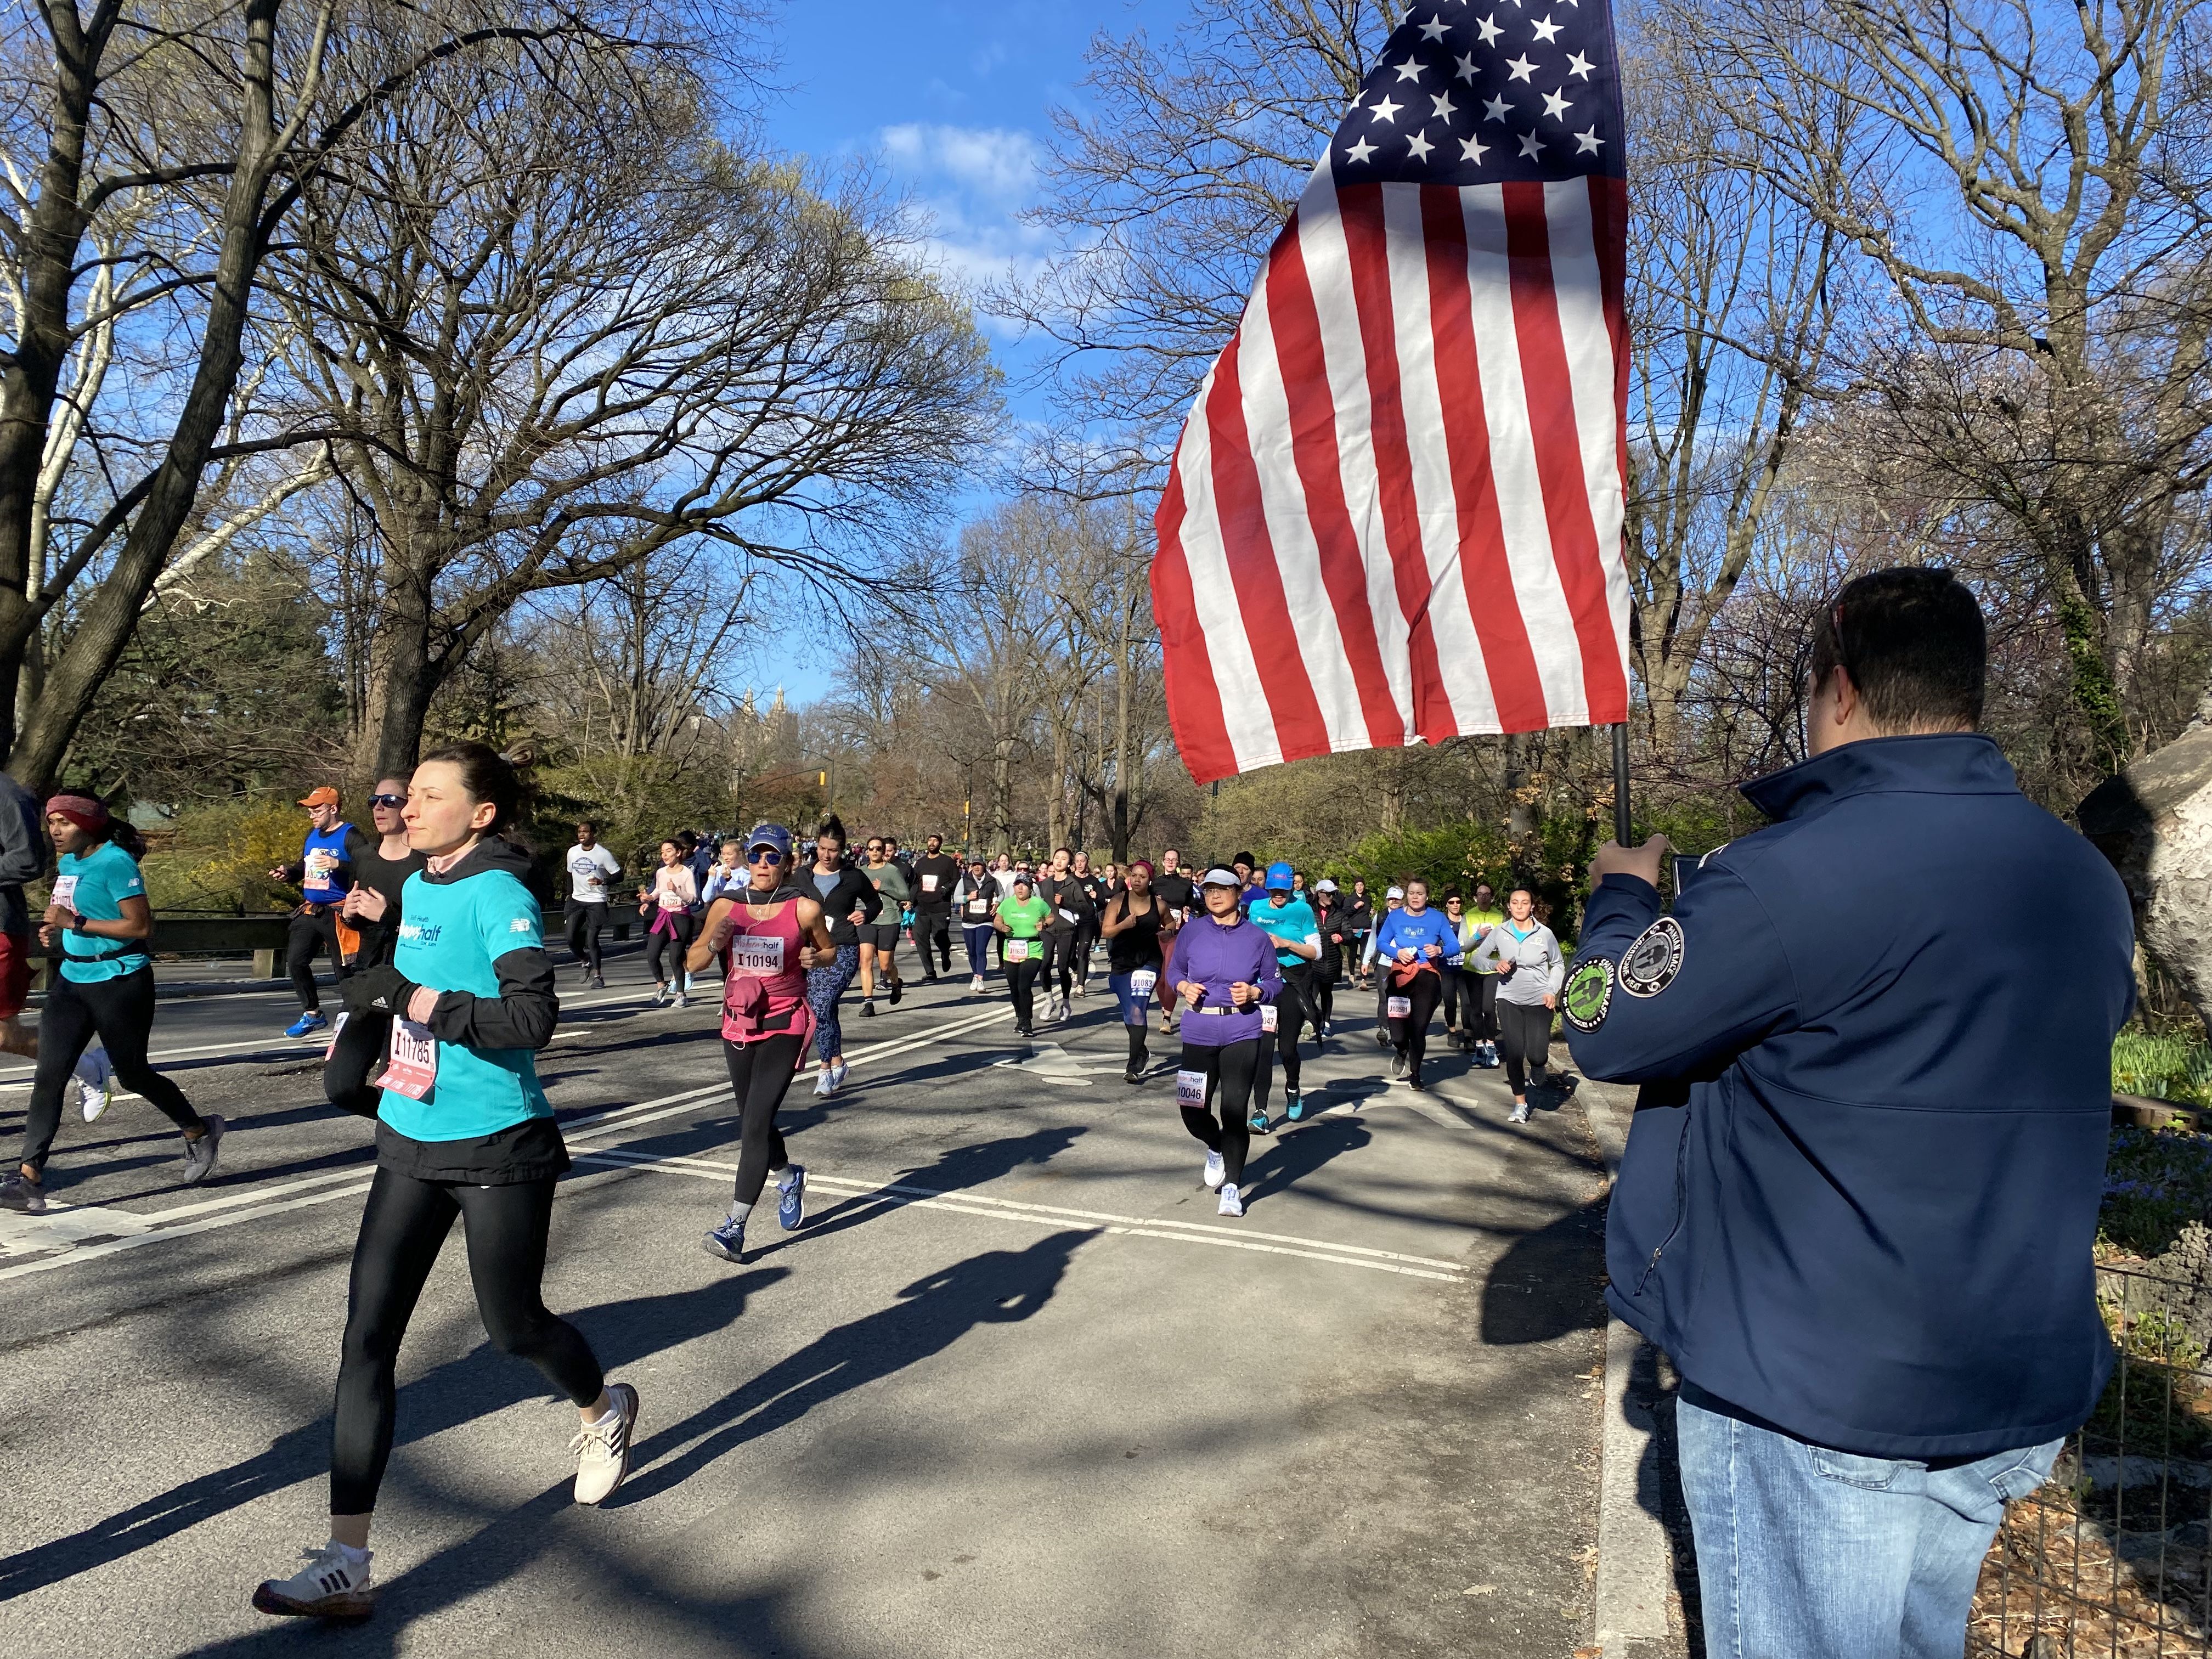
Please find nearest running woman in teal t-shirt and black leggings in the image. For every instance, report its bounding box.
[255,743,637,1619]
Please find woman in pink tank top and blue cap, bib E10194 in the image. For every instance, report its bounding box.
[686,823,836,1261]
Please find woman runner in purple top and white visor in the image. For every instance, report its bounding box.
[1166,870,1283,1215]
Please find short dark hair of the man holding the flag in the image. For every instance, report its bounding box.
[1812,564,1989,732]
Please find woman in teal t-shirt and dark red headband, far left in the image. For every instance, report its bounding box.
[0,794,223,1215]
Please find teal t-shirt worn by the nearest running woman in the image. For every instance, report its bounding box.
[376,870,553,1142]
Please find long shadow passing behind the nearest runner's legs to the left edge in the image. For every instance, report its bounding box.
[0,1267,785,1601]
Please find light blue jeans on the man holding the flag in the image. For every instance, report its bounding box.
[1674,1398,2066,1659]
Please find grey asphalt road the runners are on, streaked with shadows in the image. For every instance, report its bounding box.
[0,956,1601,1659]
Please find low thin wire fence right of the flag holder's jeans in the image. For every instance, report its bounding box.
[1966,1267,2212,1659]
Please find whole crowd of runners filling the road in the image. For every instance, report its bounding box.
[0,774,1575,1619]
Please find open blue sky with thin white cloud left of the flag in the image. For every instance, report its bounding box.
[743,0,1192,701]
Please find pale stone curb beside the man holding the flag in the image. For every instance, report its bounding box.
[1577,1080,1677,1659]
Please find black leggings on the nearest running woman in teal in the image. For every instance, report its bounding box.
[330,1168,606,1515]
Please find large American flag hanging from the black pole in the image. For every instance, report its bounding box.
[1153,0,1628,783]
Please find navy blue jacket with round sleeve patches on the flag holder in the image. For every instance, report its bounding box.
[1562,735,2135,1458]
